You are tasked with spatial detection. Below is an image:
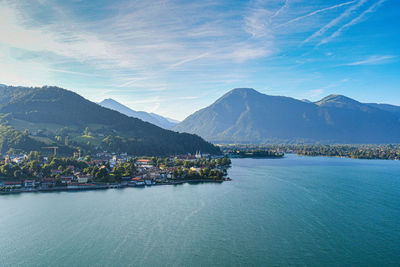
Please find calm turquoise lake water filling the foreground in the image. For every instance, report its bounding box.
[0,155,400,266]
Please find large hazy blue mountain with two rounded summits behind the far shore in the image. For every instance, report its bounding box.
[174,88,400,143]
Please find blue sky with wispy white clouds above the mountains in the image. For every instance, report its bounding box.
[0,0,400,120]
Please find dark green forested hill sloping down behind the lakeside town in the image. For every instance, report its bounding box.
[0,86,220,155]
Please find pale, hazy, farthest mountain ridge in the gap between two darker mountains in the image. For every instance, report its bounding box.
[99,98,177,130]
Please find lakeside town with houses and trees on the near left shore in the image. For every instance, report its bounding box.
[0,151,231,194]
